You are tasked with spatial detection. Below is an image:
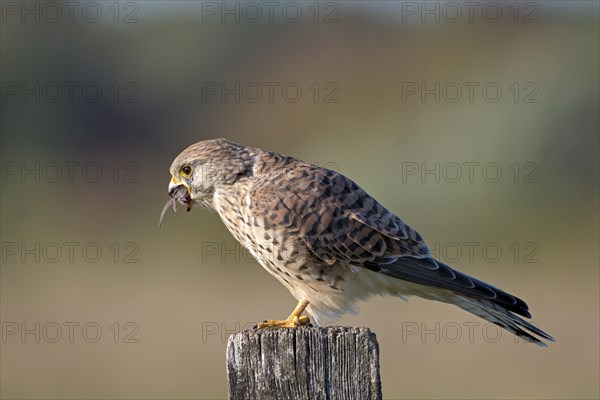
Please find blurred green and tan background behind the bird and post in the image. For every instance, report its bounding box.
[0,1,600,399]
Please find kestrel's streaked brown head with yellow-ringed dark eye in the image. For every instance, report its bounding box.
[169,139,254,208]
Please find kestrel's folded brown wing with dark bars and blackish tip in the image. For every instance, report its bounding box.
[252,164,530,317]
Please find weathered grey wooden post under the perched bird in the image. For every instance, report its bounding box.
[227,327,382,400]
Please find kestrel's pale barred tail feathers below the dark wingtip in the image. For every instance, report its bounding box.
[453,294,554,347]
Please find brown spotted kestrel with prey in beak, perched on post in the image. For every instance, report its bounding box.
[161,139,554,346]
